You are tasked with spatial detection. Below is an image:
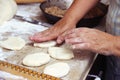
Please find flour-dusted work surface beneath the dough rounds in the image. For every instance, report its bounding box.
[0,3,104,80]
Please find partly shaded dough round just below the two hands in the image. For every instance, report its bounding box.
[48,47,74,60]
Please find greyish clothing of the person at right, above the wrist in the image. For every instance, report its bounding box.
[106,0,120,35]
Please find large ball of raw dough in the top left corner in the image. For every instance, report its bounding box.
[0,0,17,25]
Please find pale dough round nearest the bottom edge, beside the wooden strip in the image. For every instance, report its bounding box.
[44,62,70,77]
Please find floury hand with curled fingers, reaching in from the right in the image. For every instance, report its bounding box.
[58,28,116,55]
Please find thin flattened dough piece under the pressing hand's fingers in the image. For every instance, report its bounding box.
[34,41,57,48]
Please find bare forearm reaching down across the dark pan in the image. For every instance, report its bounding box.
[64,0,99,24]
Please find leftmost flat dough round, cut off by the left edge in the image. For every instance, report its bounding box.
[0,37,25,50]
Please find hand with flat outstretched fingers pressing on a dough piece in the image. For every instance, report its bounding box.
[30,19,75,42]
